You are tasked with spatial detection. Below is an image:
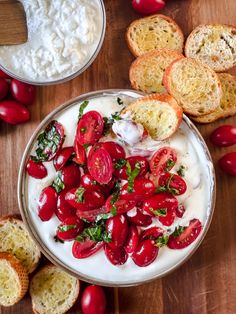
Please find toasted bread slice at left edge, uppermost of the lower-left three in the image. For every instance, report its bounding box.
[0,216,41,273]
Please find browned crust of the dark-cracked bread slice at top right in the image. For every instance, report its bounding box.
[184,23,236,72]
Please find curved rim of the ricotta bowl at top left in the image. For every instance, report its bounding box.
[0,0,106,86]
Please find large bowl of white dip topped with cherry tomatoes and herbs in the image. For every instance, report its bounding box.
[18,90,215,286]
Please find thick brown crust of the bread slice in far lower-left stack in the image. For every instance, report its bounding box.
[0,252,29,306]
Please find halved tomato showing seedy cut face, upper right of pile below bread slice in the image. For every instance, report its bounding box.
[150,147,177,176]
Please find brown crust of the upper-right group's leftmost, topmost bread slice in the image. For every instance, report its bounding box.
[125,14,184,57]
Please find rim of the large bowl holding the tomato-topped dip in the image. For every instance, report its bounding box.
[17,89,216,287]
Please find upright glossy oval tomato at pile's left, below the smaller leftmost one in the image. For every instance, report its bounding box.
[38,186,57,221]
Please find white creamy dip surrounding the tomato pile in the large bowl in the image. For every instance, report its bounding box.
[26,94,212,285]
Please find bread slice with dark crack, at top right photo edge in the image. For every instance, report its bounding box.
[185,24,236,72]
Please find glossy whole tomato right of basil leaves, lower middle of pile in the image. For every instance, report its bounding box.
[106,215,129,249]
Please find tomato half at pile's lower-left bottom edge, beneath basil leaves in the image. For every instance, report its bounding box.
[72,239,103,258]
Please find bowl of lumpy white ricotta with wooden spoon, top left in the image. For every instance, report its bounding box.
[0,0,106,85]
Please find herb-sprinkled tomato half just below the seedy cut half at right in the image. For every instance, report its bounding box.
[158,172,187,195]
